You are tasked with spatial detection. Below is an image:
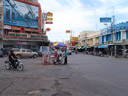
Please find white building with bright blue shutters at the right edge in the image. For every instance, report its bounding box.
[99,22,128,55]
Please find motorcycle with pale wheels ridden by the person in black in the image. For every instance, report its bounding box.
[5,59,24,71]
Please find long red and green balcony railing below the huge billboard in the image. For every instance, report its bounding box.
[4,32,47,40]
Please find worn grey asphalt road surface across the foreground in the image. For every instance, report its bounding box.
[0,54,128,96]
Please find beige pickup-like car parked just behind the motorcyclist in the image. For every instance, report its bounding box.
[13,48,38,58]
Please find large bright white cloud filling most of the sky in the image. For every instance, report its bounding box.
[39,0,128,41]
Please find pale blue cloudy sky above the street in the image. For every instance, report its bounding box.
[38,0,128,42]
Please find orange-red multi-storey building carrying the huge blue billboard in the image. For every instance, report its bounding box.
[0,0,49,48]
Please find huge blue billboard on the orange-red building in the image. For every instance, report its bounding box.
[4,0,39,28]
